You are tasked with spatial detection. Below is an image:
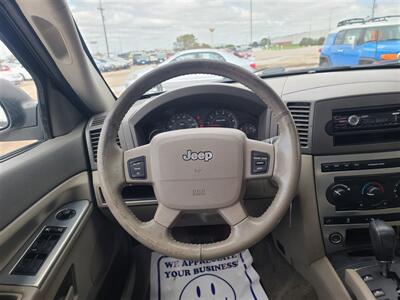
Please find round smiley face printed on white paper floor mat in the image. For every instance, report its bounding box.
[179,274,236,300]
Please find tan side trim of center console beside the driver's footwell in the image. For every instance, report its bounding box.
[273,155,351,300]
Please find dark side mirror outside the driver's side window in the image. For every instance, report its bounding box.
[0,79,43,141]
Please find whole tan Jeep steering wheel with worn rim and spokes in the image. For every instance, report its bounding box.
[97,60,300,260]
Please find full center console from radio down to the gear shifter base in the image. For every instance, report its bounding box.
[309,94,400,299]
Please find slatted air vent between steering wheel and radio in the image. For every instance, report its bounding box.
[287,102,311,148]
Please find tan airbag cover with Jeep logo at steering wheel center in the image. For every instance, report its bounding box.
[150,128,246,210]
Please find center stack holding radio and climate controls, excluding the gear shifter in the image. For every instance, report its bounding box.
[310,94,400,255]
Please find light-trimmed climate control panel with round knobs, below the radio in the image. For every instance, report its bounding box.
[314,151,400,254]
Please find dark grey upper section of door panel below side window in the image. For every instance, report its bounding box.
[0,124,87,230]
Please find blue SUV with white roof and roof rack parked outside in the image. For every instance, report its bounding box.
[319,16,400,67]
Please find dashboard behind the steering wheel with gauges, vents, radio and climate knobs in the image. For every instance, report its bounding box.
[86,70,400,255]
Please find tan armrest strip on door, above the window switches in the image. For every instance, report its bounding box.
[0,172,92,270]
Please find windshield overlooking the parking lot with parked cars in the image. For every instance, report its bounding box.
[68,0,400,96]
